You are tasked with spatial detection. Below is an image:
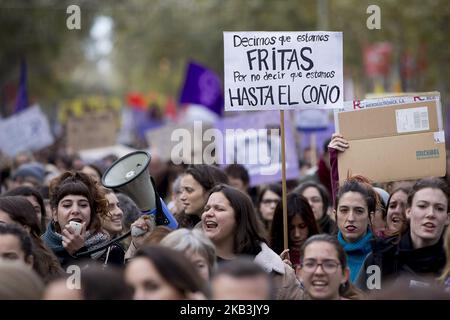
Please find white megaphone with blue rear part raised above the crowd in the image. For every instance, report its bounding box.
[102,151,178,229]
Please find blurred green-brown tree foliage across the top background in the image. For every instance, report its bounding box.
[0,0,450,109]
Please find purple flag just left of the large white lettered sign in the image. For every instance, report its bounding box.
[180,62,224,115]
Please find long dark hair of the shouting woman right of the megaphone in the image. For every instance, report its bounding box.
[210,184,267,255]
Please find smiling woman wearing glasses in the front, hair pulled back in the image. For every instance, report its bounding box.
[297,234,362,300]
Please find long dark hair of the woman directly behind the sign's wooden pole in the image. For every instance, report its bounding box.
[270,193,319,254]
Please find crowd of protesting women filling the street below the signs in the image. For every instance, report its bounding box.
[0,125,450,300]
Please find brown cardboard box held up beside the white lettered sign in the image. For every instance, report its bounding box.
[336,100,446,184]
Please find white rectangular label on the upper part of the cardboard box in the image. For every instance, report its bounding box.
[395,107,430,133]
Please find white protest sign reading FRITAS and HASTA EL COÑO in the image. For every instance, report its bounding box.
[224,31,344,111]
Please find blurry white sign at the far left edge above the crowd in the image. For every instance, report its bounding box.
[0,105,54,157]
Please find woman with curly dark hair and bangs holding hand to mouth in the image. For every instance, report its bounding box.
[42,171,109,267]
